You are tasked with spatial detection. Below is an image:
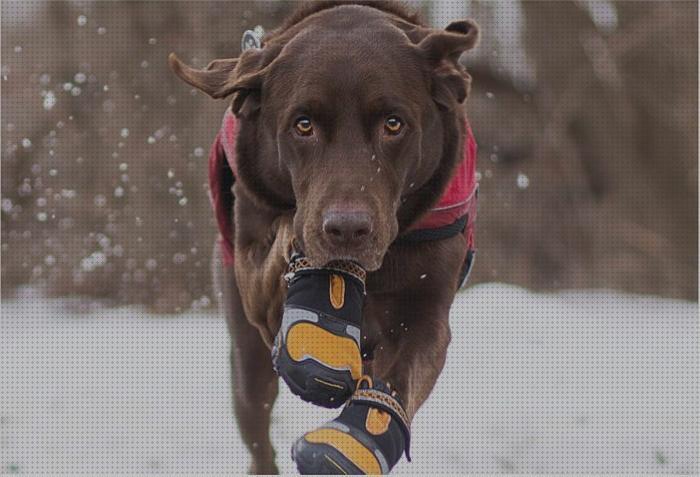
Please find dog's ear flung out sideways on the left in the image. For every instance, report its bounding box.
[168,48,277,117]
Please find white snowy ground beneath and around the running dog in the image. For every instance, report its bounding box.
[0,285,699,474]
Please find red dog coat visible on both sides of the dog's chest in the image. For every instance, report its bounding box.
[209,108,478,275]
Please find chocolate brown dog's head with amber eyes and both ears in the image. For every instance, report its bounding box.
[170,5,478,270]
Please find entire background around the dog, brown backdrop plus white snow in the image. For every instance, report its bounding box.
[0,0,700,475]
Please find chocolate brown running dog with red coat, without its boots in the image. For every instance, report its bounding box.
[169,1,479,474]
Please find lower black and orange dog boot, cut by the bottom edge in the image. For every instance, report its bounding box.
[292,377,411,474]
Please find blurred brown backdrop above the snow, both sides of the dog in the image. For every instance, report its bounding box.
[2,1,698,312]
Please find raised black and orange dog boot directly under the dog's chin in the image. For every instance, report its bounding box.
[272,254,365,408]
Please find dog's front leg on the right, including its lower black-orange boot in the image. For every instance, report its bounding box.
[293,236,466,474]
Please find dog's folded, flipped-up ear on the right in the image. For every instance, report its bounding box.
[414,20,479,109]
